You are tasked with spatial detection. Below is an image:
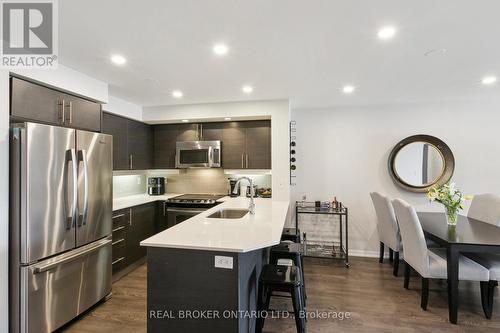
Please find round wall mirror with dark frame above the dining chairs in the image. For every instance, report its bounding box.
[389,135,455,192]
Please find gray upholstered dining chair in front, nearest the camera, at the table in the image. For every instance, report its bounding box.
[392,199,489,315]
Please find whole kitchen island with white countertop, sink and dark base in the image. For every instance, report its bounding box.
[141,197,289,333]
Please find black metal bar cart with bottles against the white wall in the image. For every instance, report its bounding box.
[295,201,349,268]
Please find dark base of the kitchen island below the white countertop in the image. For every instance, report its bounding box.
[147,247,263,333]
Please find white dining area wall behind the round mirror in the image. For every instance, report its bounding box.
[291,101,500,255]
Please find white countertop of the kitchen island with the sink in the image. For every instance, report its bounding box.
[141,197,290,252]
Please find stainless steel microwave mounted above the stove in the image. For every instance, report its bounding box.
[175,141,221,169]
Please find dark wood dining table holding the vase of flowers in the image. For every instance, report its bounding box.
[418,212,500,324]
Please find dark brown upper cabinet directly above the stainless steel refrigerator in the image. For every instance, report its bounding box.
[10,77,101,132]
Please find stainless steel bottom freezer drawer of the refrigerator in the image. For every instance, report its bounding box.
[20,238,112,333]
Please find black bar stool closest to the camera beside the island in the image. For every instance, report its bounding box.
[255,264,306,333]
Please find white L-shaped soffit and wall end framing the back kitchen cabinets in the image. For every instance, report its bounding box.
[142,100,290,200]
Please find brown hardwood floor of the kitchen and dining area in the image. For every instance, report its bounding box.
[63,258,500,333]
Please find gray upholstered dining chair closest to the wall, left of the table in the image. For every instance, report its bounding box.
[370,192,401,276]
